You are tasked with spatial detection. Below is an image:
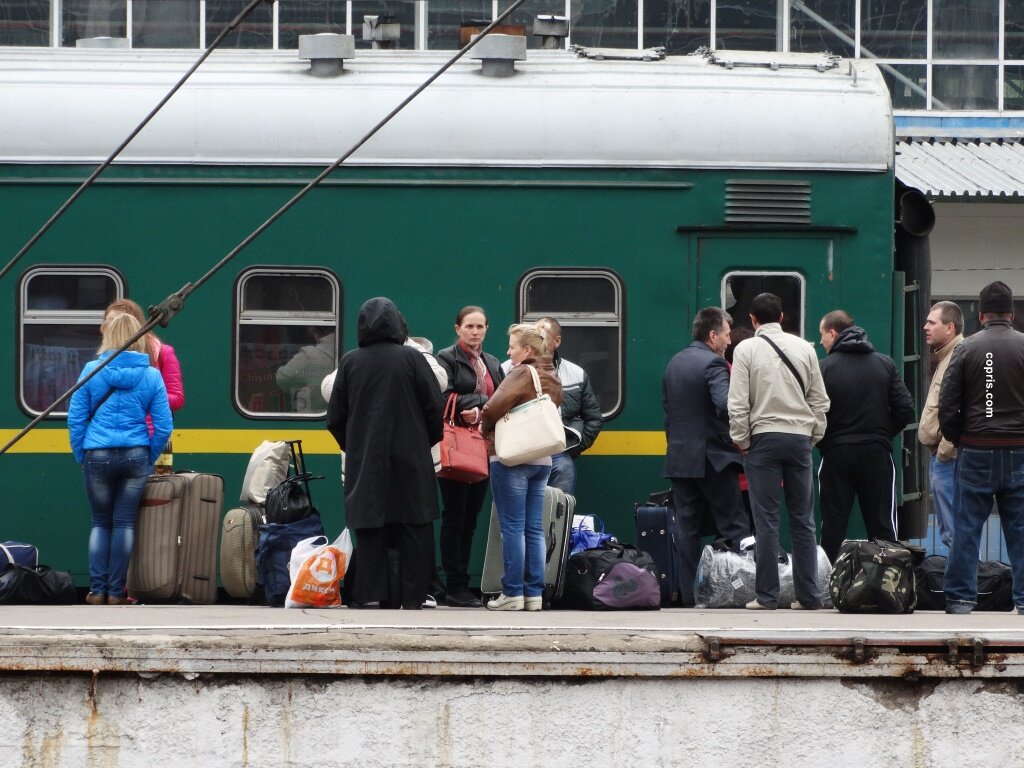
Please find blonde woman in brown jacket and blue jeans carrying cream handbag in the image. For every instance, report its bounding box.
[482,325,562,610]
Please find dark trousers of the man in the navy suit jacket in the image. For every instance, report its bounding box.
[672,463,751,607]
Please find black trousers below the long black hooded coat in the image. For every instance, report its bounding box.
[351,522,434,609]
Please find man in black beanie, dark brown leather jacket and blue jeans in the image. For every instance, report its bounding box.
[939,281,1024,613]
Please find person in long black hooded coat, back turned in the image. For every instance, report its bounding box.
[327,298,442,609]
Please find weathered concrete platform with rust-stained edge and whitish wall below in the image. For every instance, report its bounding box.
[0,605,1024,768]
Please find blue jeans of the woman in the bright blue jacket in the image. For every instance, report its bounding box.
[82,446,153,597]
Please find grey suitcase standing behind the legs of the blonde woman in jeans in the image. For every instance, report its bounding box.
[480,485,575,606]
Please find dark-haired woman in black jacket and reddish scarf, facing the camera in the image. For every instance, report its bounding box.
[437,306,505,608]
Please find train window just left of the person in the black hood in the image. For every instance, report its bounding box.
[234,267,341,419]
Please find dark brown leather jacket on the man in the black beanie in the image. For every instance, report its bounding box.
[939,321,1024,447]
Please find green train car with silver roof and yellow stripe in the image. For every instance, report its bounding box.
[0,49,927,577]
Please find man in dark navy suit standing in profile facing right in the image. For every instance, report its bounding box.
[662,306,751,606]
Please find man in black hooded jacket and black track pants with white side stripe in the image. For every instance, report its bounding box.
[818,309,914,562]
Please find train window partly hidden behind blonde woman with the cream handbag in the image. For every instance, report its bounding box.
[517,269,625,419]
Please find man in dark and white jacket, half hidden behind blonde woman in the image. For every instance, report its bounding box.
[502,317,604,496]
